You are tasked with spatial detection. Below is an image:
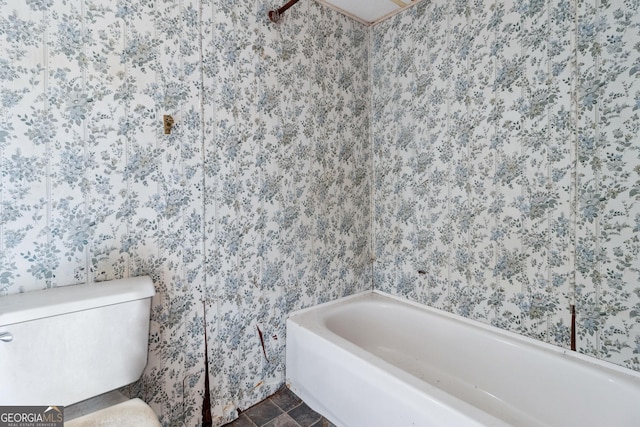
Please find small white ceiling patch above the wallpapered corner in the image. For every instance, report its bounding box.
[316,0,421,25]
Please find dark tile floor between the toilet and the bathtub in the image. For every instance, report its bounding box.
[223,386,335,427]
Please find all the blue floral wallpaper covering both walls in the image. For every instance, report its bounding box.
[0,0,640,426]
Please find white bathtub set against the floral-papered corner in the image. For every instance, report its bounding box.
[286,292,640,427]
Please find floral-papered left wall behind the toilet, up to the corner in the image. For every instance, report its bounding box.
[0,0,371,426]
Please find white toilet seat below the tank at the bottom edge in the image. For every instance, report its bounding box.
[64,398,161,427]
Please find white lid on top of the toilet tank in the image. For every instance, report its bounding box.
[0,276,155,326]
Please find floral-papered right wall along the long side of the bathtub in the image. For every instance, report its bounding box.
[371,0,640,370]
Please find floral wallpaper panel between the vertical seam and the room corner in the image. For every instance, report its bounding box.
[202,1,372,420]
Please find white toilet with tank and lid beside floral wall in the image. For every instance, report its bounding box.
[0,276,160,427]
